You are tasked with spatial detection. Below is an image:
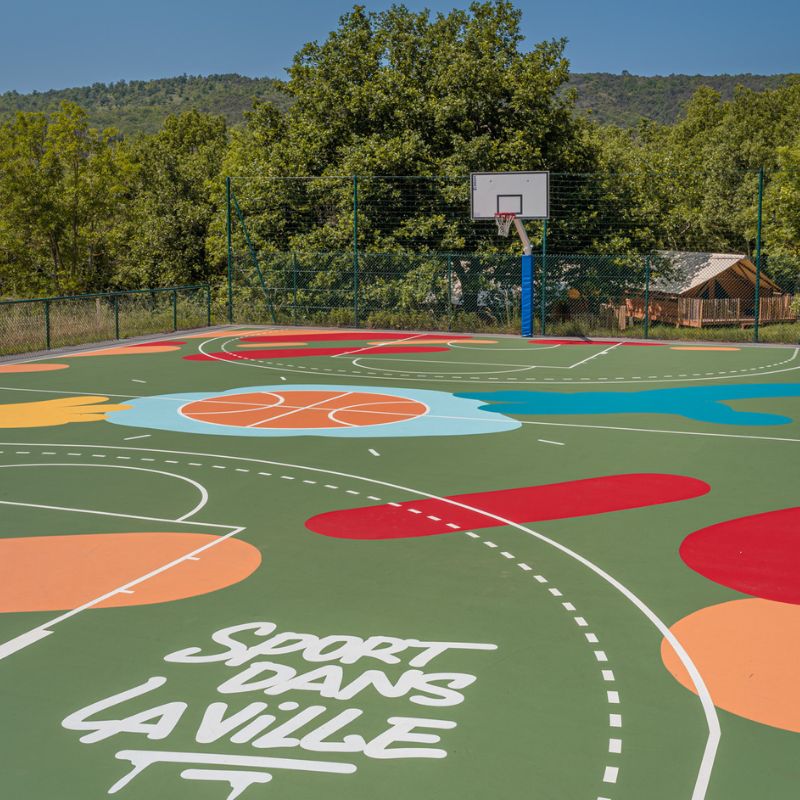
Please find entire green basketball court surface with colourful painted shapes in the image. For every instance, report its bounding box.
[0,328,800,800]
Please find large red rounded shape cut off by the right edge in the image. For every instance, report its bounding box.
[680,508,800,604]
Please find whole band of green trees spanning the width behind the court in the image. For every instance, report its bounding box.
[0,0,800,297]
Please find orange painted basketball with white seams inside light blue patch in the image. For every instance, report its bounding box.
[181,389,428,430]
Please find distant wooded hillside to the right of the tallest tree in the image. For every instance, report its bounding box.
[569,72,790,127]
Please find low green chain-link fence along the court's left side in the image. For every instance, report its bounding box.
[0,286,211,355]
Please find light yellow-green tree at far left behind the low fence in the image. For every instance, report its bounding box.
[0,102,130,295]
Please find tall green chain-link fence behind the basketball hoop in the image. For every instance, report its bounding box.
[227,172,800,342]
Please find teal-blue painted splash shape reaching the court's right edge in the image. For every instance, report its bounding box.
[456,383,800,426]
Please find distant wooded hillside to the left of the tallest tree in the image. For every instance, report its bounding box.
[0,74,290,135]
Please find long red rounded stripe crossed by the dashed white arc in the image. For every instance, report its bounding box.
[306,473,710,539]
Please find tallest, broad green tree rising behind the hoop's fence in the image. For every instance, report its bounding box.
[218,0,594,316]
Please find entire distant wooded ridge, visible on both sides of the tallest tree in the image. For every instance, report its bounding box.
[0,72,790,135]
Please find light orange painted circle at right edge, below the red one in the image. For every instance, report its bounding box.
[661,599,800,733]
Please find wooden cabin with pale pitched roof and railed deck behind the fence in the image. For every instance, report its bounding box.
[626,252,797,328]
